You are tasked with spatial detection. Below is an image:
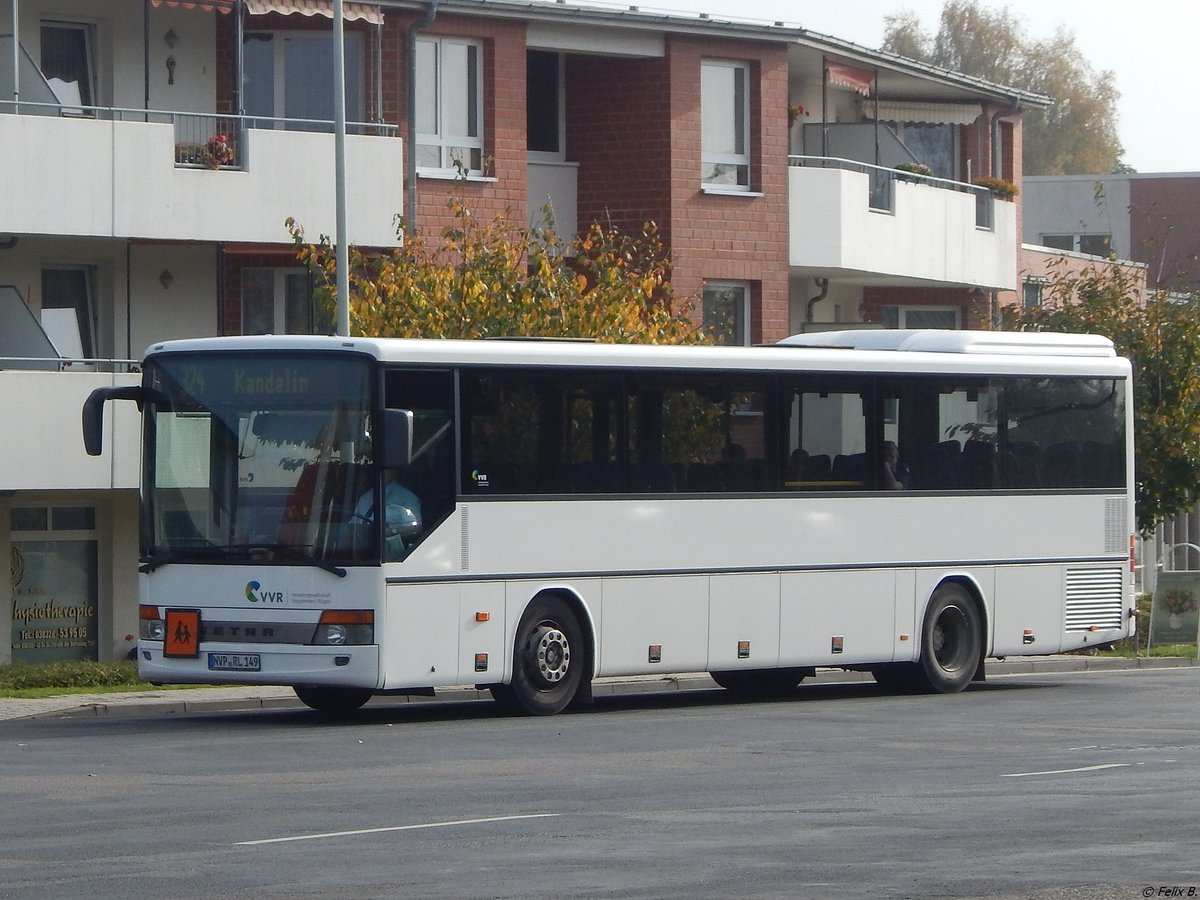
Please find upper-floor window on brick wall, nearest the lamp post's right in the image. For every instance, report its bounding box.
[416,37,484,174]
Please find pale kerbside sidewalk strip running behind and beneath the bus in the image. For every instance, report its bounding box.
[0,655,1200,721]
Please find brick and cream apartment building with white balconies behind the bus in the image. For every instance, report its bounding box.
[0,0,1046,662]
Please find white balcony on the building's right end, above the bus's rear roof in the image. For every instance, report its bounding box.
[788,156,1016,290]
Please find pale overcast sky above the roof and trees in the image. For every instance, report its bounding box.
[583,0,1200,173]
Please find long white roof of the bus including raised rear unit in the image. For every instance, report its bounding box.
[145,330,1129,377]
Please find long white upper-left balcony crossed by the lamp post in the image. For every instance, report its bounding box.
[0,101,403,247]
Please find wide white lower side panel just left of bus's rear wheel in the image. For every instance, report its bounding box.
[779,569,896,666]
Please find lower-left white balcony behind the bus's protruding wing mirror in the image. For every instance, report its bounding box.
[0,367,140,491]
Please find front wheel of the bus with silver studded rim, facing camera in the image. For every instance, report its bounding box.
[492,596,588,715]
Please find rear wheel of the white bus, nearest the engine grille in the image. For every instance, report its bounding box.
[917,582,983,694]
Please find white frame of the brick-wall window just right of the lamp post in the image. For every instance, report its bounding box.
[413,37,485,176]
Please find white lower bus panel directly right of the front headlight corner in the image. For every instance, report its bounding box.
[380,582,458,690]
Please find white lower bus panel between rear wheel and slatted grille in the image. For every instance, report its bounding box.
[991,565,1063,656]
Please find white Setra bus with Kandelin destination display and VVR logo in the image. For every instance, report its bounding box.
[84,331,1134,714]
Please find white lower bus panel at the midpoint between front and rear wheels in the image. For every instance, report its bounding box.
[708,572,781,671]
